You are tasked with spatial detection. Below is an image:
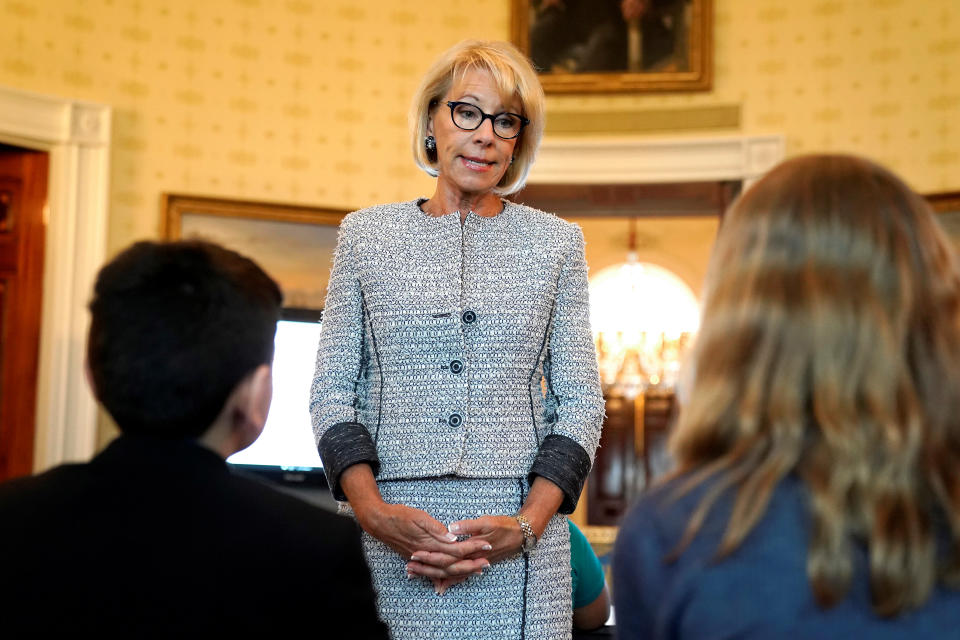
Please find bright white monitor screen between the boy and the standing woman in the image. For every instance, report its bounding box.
[227,309,325,484]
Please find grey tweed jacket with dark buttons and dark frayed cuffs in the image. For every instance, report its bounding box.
[310,201,604,513]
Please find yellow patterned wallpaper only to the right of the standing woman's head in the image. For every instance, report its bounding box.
[552,0,960,192]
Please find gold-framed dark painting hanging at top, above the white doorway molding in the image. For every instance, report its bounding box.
[511,0,713,93]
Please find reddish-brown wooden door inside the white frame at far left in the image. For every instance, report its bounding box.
[0,145,48,481]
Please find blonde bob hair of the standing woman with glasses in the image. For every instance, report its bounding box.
[410,40,546,195]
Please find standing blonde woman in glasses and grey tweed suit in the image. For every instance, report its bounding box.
[311,42,603,640]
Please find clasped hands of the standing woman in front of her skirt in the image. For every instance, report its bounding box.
[355,502,523,595]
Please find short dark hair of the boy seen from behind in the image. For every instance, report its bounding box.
[87,241,282,437]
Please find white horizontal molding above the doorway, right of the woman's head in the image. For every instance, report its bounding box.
[528,135,786,184]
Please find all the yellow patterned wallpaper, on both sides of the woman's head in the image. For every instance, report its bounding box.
[0,0,960,252]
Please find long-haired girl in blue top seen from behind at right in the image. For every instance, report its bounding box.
[613,156,960,640]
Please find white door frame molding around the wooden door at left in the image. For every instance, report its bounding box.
[0,87,111,471]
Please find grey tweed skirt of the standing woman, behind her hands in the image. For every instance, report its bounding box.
[342,476,572,640]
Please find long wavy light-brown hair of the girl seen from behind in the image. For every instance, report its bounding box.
[670,155,960,616]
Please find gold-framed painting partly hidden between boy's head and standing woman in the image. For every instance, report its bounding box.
[162,193,348,309]
